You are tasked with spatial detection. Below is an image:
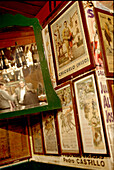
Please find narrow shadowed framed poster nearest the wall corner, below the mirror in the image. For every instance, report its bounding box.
[30,114,44,154]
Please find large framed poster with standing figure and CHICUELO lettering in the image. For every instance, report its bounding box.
[49,1,95,84]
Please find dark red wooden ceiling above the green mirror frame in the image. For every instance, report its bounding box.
[0,1,47,18]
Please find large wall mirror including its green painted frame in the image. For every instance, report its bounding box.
[0,14,61,119]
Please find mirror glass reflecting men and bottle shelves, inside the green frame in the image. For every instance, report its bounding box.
[0,26,47,113]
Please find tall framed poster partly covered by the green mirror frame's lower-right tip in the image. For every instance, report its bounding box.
[56,82,81,155]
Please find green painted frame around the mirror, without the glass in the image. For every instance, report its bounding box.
[0,14,61,119]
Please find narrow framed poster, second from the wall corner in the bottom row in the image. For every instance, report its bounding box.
[42,111,59,155]
